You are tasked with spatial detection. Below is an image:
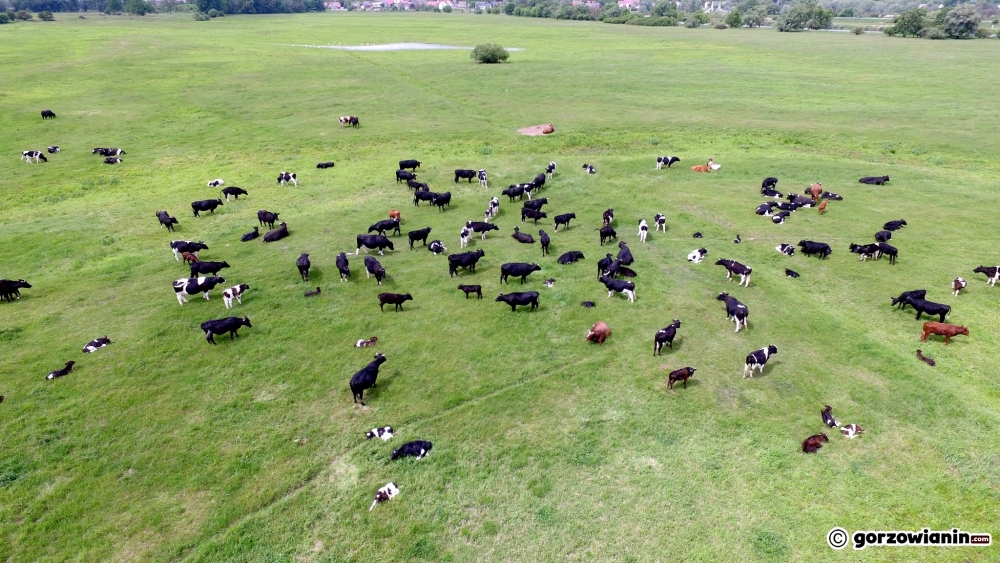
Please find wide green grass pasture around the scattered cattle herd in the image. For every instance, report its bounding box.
[0,14,1000,562]
